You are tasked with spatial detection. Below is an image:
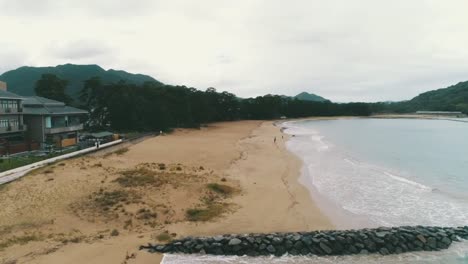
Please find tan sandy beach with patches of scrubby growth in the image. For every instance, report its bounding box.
[0,121,333,264]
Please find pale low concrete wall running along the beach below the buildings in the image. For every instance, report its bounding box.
[0,139,122,185]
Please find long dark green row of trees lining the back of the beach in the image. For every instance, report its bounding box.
[35,75,371,131]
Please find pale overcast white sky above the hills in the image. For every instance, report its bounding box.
[0,0,468,102]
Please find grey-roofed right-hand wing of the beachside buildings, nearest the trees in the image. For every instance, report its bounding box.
[23,96,88,148]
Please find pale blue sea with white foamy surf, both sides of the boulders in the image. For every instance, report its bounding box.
[163,118,468,264]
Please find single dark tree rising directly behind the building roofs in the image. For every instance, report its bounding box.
[34,74,72,104]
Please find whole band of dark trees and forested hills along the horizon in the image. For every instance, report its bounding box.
[4,64,468,132]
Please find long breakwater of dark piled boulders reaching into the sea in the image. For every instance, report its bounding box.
[140,226,468,256]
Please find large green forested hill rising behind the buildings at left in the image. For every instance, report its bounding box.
[0,64,158,98]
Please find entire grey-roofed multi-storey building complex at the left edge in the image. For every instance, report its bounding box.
[0,82,88,155]
